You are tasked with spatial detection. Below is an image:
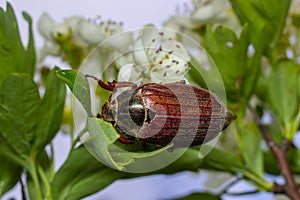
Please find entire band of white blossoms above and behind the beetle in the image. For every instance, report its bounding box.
[39,0,240,82]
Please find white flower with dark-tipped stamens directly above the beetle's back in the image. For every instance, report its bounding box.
[118,25,190,83]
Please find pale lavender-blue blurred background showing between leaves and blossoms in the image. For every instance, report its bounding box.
[0,0,280,200]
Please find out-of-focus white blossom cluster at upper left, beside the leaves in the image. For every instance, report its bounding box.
[38,13,132,65]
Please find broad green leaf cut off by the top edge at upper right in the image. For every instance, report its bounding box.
[230,0,291,50]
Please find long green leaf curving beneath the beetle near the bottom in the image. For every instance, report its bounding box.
[52,146,206,200]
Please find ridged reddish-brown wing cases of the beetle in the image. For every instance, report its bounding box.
[137,83,235,147]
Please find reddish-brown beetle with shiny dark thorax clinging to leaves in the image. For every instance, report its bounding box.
[86,75,236,148]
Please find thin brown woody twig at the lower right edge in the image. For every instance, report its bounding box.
[251,109,300,200]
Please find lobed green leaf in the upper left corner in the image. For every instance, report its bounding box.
[0,3,35,86]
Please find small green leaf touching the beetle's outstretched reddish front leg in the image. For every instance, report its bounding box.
[56,70,93,117]
